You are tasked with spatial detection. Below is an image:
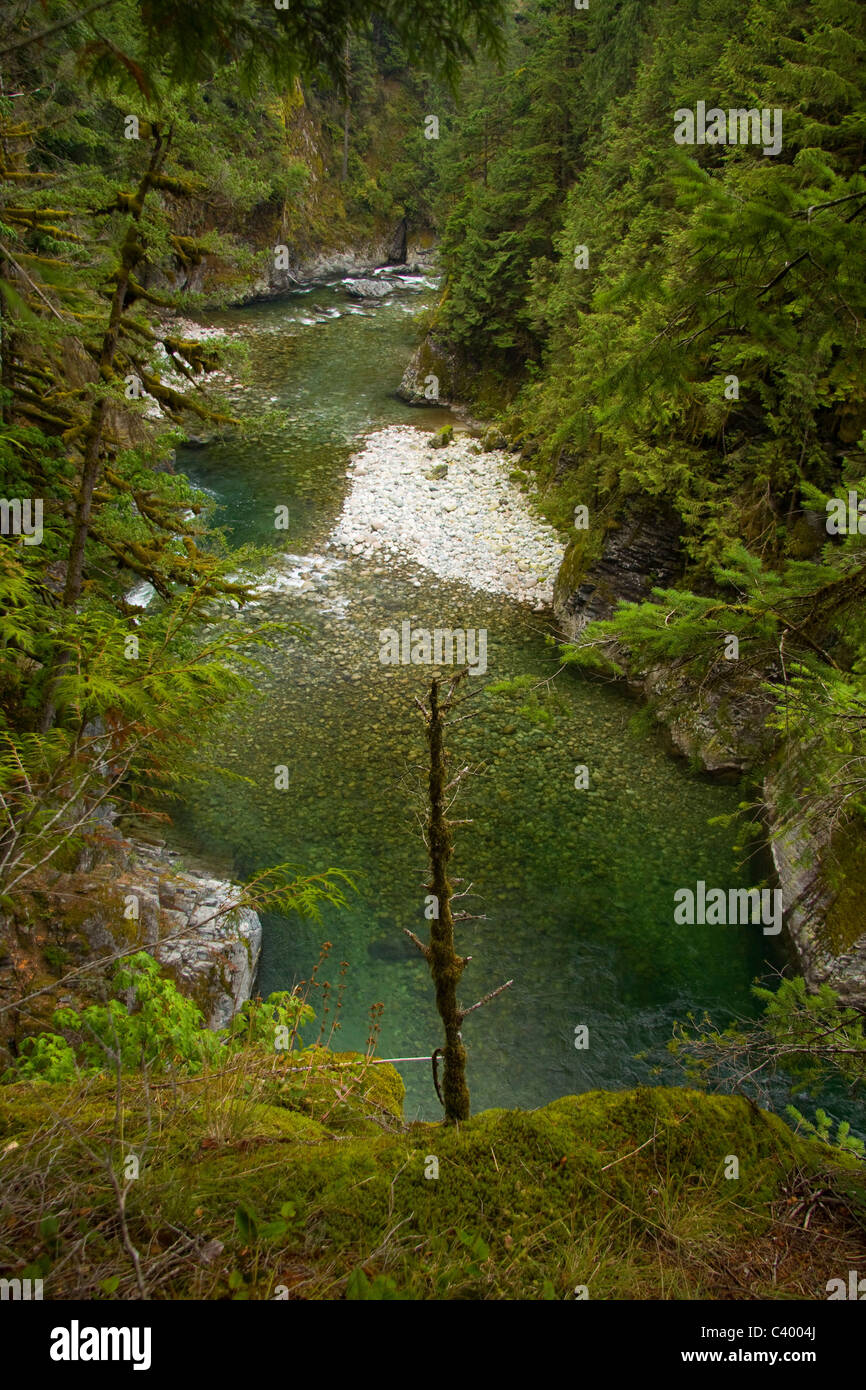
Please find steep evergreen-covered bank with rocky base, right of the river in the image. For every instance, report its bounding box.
[402,0,866,1005]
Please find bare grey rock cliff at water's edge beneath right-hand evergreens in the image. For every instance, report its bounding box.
[553,503,866,1008]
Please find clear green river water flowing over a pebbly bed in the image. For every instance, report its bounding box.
[169,284,781,1119]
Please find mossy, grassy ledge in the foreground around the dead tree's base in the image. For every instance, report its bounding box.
[0,1049,866,1300]
